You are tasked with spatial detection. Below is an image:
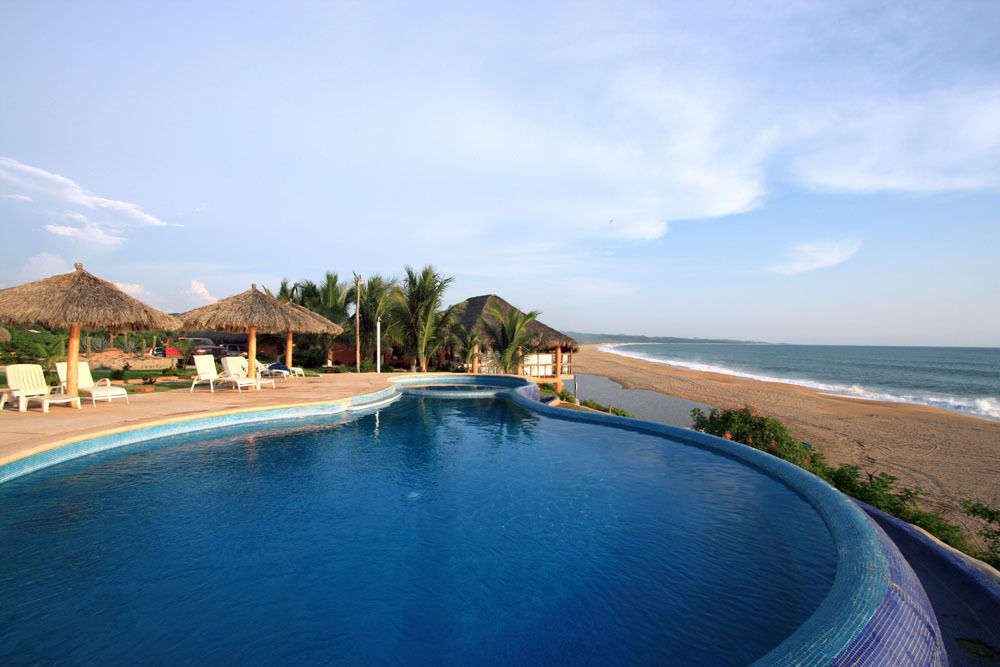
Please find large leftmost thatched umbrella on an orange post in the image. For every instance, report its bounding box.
[0,262,181,396]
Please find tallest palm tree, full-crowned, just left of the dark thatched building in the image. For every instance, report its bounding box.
[393,264,461,372]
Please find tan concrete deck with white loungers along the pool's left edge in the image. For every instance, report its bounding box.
[0,373,398,466]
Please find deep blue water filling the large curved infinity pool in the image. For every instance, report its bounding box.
[0,398,836,664]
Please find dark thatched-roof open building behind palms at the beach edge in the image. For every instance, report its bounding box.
[459,294,580,390]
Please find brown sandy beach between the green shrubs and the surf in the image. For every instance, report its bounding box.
[573,345,1000,529]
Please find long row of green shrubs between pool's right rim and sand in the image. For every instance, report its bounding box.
[691,406,969,551]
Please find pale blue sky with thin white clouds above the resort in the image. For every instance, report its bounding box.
[0,0,1000,346]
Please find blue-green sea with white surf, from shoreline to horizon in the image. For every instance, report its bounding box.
[601,343,1000,419]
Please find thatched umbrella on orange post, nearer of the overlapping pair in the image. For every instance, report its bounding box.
[178,285,336,377]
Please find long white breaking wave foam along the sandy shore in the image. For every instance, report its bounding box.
[597,343,1000,420]
